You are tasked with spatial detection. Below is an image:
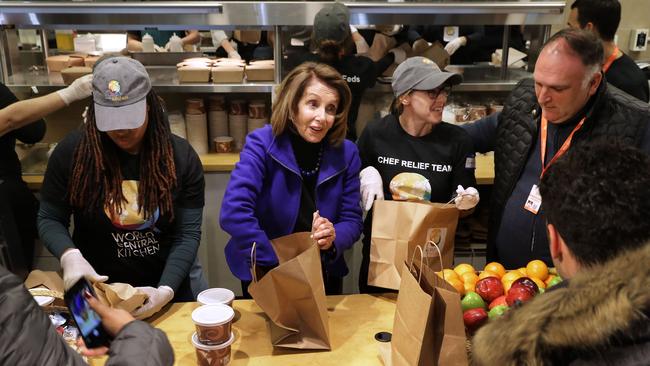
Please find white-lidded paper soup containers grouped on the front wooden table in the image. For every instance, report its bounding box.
[192,288,235,366]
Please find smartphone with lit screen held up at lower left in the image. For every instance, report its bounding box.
[64,277,110,348]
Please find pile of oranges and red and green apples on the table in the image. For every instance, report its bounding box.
[437,260,562,333]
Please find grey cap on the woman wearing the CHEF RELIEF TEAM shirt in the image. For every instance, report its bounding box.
[392,56,463,97]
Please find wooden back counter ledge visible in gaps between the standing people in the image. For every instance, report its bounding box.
[23,153,494,190]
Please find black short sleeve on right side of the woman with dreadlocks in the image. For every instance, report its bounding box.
[173,137,205,208]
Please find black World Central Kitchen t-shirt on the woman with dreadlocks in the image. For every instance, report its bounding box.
[41,131,204,287]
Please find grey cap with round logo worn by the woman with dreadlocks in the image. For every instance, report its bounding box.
[93,56,151,131]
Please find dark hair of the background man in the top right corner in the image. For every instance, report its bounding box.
[571,0,621,42]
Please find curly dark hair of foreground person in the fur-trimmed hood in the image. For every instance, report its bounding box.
[540,140,650,265]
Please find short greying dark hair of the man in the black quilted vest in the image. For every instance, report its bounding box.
[544,28,604,69]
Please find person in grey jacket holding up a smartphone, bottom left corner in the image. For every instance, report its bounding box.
[0,265,174,366]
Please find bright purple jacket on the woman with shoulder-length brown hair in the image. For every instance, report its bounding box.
[219,125,363,281]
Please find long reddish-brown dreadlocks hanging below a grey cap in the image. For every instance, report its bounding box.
[68,89,176,220]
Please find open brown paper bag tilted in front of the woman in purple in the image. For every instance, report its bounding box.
[248,232,331,350]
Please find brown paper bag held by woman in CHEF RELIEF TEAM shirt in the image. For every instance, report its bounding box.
[368,200,458,290]
